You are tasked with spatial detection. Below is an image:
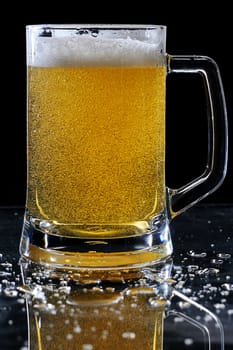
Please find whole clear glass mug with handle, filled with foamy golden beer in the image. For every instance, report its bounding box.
[20,24,227,269]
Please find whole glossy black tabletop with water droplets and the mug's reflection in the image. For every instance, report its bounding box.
[0,204,233,350]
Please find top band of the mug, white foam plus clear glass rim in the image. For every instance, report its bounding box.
[27,25,166,67]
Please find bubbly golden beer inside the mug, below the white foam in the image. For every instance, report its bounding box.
[27,65,166,237]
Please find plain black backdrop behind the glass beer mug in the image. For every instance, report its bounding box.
[0,1,233,206]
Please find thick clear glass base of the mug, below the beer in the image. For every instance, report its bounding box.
[20,217,172,270]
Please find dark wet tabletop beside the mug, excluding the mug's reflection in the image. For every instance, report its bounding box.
[0,204,233,350]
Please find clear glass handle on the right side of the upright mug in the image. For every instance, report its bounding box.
[167,55,228,218]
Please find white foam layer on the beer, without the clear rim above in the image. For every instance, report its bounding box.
[27,36,164,67]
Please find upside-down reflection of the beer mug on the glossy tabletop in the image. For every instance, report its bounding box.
[21,264,225,350]
